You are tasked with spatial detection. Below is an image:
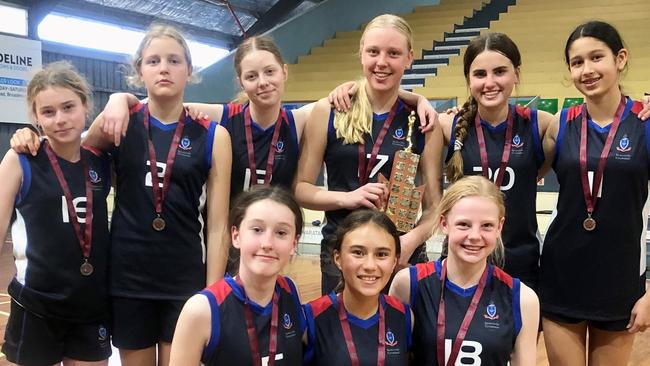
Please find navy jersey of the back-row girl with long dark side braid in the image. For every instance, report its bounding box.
[447,106,544,282]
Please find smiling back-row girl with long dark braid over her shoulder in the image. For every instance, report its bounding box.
[434,33,554,289]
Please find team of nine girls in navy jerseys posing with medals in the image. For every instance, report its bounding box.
[0,7,650,366]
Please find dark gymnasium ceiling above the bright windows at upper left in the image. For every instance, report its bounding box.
[10,0,325,49]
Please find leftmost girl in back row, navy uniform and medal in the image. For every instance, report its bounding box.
[0,62,111,365]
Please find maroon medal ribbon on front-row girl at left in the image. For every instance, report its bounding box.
[235,277,280,366]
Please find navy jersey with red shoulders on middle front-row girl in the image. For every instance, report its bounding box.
[305,292,411,366]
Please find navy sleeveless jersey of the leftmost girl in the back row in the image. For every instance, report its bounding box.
[9,144,111,322]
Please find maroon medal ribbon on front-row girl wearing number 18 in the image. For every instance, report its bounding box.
[436,260,488,366]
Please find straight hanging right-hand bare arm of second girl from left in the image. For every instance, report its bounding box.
[206,126,232,285]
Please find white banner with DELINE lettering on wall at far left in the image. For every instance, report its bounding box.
[0,35,42,123]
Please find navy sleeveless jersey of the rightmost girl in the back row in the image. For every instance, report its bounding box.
[540,100,650,321]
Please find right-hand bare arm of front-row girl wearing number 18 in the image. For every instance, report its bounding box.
[510,283,539,366]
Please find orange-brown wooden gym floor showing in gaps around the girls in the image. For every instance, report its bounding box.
[0,242,650,366]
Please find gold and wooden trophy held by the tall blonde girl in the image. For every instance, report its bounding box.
[378,111,424,233]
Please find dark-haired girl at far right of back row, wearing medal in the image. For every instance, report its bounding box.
[540,21,650,365]
